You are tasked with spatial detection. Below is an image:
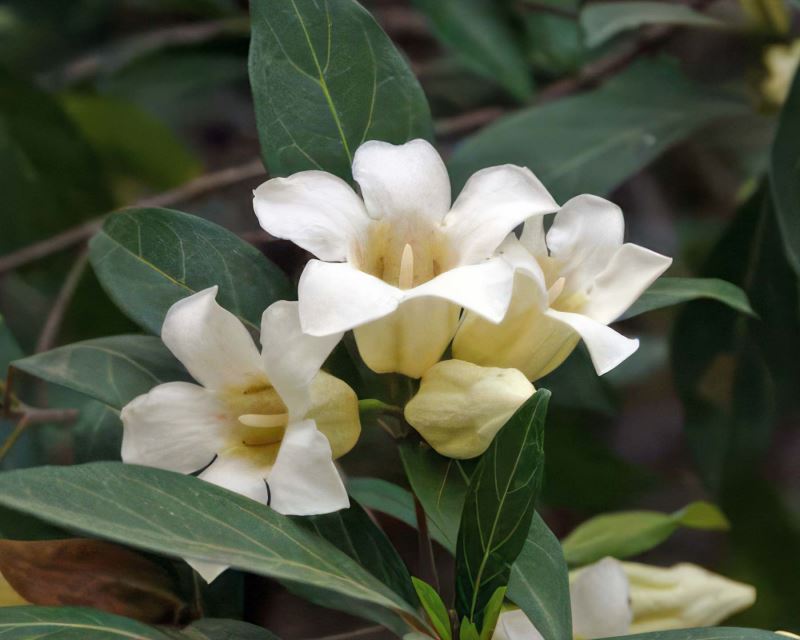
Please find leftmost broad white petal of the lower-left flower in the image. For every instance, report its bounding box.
[121,382,226,473]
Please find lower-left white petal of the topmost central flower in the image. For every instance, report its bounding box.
[298,260,403,336]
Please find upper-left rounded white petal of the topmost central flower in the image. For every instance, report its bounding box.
[253,171,369,261]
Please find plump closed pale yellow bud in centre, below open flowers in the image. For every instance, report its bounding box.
[405,360,535,459]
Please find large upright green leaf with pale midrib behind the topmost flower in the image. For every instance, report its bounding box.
[250,0,432,180]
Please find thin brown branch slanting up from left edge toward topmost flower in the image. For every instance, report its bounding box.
[0,158,265,275]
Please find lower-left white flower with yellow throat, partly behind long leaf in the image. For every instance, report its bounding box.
[122,287,361,580]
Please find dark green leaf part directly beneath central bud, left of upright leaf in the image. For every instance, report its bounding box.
[400,440,474,553]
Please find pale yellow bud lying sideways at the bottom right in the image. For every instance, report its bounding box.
[622,562,756,633]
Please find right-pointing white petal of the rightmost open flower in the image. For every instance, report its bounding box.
[582,243,672,324]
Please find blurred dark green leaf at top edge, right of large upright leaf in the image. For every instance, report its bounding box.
[413,0,533,101]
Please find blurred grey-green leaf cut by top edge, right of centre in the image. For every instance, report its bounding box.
[580,1,725,47]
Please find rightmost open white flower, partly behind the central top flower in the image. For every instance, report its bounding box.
[453,195,672,380]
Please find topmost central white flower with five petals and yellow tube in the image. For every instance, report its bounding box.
[254,140,558,378]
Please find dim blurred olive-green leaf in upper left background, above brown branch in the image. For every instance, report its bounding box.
[62,93,201,190]
